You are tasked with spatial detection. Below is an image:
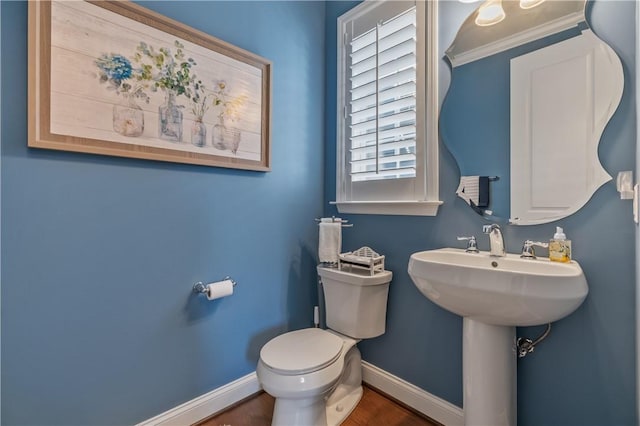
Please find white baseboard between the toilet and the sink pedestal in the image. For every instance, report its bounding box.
[362,361,464,426]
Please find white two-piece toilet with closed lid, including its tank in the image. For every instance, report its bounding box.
[256,266,393,426]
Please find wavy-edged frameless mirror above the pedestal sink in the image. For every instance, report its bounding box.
[440,0,624,225]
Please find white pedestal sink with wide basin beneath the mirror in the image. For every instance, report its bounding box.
[409,248,589,426]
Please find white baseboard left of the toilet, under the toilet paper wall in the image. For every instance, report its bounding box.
[136,372,262,426]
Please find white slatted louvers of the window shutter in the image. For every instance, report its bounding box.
[349,7,417,182]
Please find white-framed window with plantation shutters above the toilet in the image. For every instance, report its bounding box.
[335,1,441,215]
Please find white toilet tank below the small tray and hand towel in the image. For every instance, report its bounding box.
[318,266,393,339]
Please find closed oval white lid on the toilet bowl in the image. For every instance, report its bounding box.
[260,328,343,374]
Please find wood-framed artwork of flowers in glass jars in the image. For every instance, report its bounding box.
[28,0,271,171]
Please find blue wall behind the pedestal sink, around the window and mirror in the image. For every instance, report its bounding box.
[325,1,637,426]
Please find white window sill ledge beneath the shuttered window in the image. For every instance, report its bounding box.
[330,201,442,216]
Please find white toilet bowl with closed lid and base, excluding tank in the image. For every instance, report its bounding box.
[257,328,362,426]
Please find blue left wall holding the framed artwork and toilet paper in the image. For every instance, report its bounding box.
[1,1,325,425]
